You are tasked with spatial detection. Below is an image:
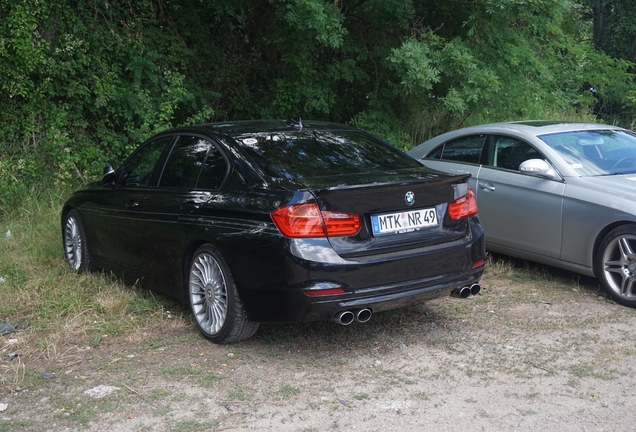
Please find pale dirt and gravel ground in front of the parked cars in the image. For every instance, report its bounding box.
[0,275,636,431]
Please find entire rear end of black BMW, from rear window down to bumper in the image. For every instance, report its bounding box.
[221,123,485,324]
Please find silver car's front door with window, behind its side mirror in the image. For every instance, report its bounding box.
[475,136,565,258]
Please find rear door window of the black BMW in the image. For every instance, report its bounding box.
[159,136,211,189]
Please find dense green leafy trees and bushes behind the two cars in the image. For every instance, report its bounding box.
[0,0,636,213]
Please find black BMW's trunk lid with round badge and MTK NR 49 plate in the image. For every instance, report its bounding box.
[297,169,469,258]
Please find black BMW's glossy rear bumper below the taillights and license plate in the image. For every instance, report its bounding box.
[230,218,485,322]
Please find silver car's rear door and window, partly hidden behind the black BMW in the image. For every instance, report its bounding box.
[412,135,486,190]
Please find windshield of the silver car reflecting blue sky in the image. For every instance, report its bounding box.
[539,130,636,176]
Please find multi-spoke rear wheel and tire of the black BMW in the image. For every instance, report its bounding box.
[187,244,259,344]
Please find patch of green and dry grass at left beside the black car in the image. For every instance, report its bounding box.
[0,186,184,390]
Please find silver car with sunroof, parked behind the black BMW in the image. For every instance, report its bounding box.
[408,121,636,307]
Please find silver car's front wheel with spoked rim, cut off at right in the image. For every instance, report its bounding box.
[596,225,636,307]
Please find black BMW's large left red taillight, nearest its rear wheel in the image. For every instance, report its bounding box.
[271,203,361,238]
